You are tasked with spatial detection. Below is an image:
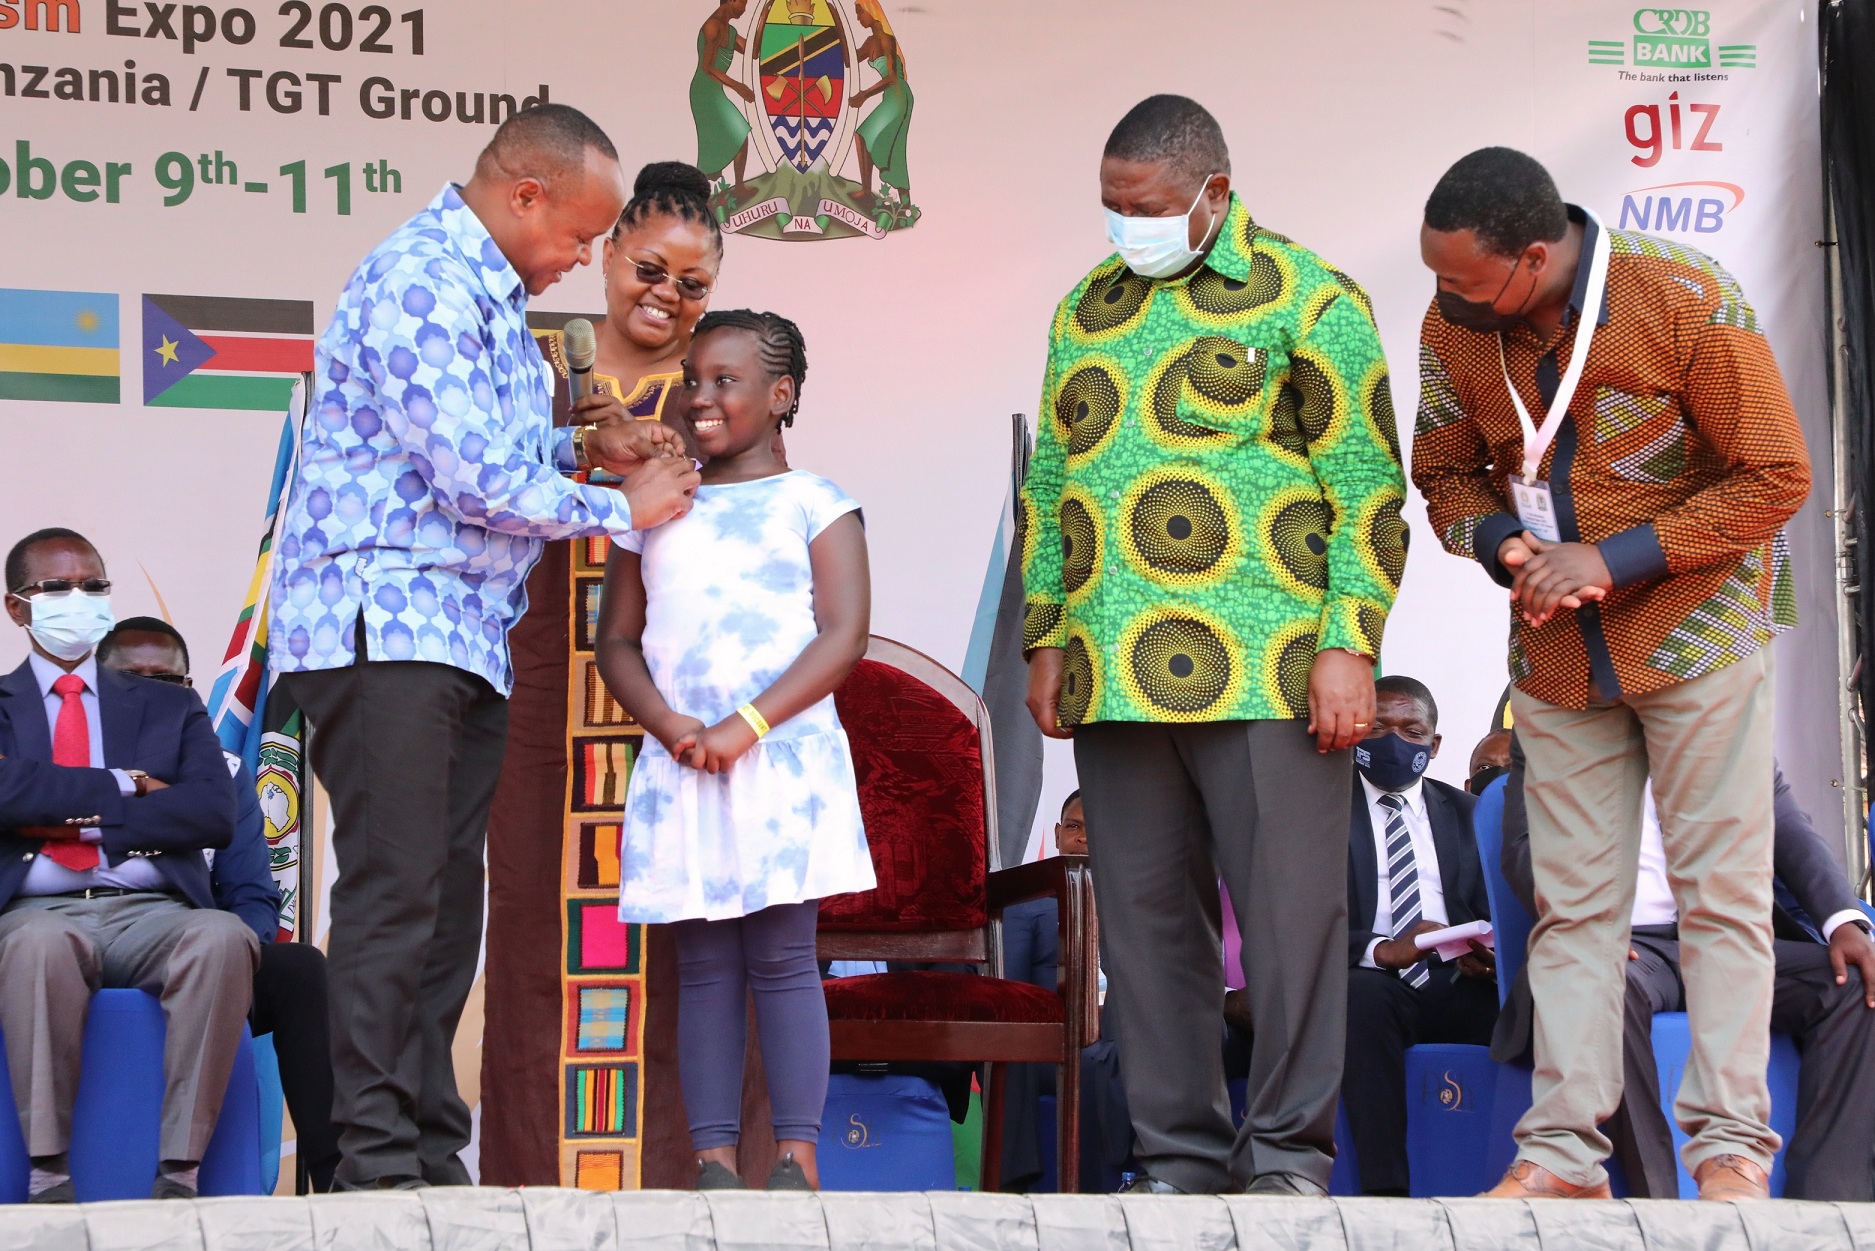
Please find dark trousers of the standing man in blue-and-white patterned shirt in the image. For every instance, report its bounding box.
[283,660,510,1185]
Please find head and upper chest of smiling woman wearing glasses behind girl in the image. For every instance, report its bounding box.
[534,161,722,456]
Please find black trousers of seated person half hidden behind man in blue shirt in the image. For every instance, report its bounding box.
[248,943,339,1195]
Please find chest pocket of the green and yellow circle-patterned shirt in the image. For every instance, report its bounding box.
[1151,334,1294,446]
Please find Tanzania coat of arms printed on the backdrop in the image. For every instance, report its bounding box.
[690,0,919,238]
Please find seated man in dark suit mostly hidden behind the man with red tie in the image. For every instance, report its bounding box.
[98,617,339,1193]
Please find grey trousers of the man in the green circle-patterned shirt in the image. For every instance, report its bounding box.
[1074,720,1352,1193]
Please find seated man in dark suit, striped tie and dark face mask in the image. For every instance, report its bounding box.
[1341,677,1498,1195]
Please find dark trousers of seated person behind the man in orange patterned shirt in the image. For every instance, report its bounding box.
[1607,930,1875,1202]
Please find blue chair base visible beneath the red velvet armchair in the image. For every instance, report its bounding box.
[818,1073,956,1191]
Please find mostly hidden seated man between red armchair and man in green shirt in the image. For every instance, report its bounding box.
[1001,791,1133,1195]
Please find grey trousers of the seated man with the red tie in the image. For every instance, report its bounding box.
[0,891,261,1161]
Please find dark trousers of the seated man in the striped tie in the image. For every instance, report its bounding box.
[1341,964,1498,1195]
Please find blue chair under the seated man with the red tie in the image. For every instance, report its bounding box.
[0,990,264,1202]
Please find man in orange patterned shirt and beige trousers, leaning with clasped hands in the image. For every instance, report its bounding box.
[1412,148,1809,1198]
